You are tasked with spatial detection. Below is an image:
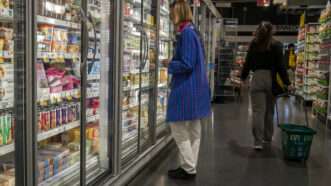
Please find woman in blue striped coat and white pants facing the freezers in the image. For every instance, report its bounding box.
[164,0,211,179]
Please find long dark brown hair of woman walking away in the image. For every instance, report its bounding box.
[254,21,273,51]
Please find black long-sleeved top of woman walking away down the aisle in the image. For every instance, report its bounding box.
[241,41,291,85]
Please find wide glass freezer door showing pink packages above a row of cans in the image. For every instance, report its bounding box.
[34,0,82,186]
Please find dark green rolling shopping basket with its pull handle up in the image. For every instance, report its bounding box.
[275,93,316,161]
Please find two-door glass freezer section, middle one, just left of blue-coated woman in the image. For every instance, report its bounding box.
[121,0,157,164]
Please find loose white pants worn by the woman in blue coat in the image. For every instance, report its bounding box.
[170,120,201,174]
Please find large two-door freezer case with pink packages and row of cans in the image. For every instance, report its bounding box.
[34,0,110,185]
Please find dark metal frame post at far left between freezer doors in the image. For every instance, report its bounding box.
[12,0,34,186]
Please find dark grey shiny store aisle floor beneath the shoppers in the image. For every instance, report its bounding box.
[129,94,331,186]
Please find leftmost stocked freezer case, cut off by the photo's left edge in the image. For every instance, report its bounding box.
[0,0,19,186]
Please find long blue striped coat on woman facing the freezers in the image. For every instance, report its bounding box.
[166,24,211,122]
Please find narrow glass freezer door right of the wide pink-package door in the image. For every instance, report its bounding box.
[85,0,112,183]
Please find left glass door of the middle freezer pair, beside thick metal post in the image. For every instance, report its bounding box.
[120,0,144,165]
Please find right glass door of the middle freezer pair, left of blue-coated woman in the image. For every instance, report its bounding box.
[139,0,157,151]
